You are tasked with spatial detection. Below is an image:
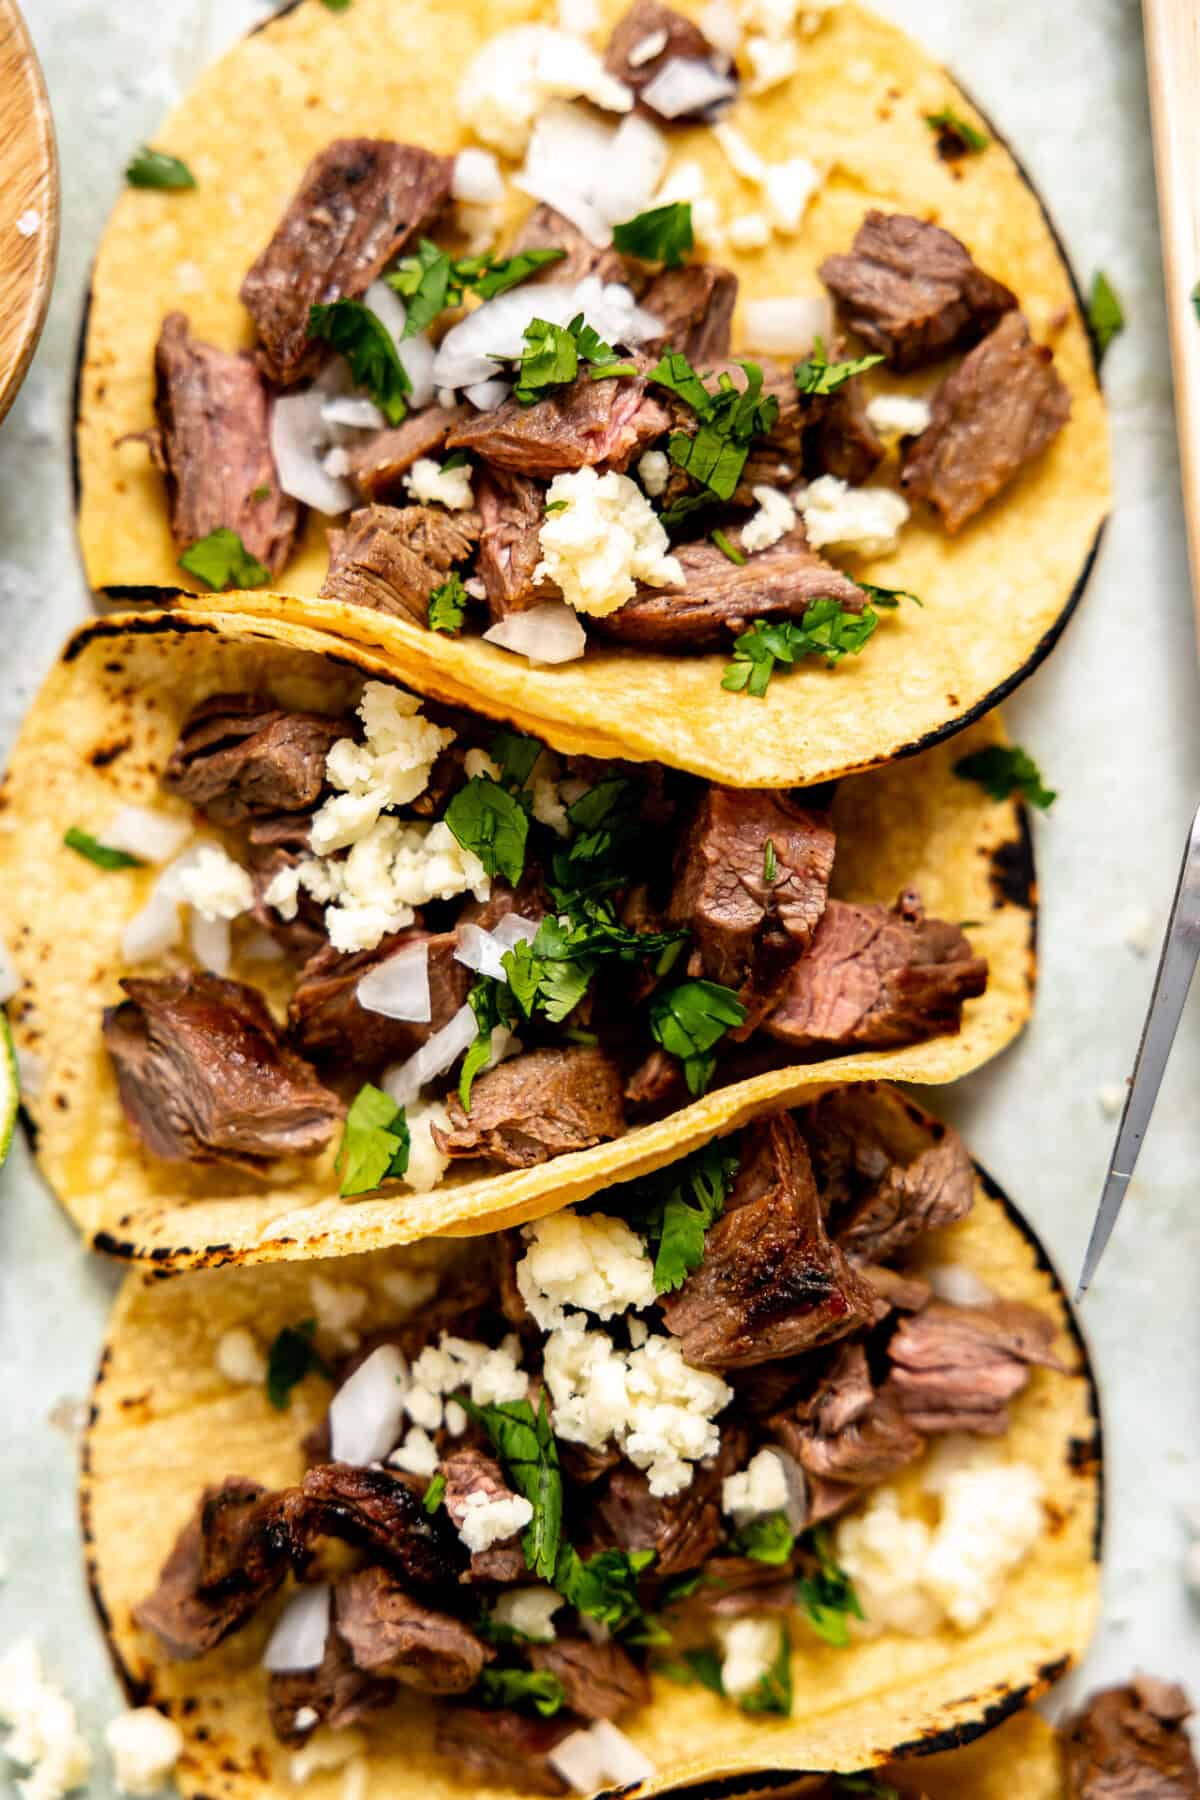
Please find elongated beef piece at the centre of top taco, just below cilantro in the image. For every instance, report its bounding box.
[446,374,671,479]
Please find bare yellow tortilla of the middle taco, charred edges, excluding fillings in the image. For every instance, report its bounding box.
[0,614,1034,1267]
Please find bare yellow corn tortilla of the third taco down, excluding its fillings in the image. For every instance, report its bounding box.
[83,1144,1101,1800]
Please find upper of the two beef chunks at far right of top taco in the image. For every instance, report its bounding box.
[820,211,1016,369]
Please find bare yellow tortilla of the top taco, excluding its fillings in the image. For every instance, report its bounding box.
[77,0,1108,787]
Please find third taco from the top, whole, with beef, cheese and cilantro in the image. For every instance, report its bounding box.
[83,1084,1099,1800]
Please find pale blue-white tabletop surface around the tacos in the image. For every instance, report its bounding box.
[0,0,1200,1795]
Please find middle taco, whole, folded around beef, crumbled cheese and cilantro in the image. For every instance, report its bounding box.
[0,614,1033,1265]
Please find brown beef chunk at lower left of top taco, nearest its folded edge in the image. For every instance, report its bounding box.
[320,506,479,625]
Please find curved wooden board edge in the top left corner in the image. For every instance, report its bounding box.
[0,0,58,419]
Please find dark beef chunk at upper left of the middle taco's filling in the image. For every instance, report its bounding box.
[162,693,347,824]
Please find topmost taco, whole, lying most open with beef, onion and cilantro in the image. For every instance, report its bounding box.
[77,0,1108,787]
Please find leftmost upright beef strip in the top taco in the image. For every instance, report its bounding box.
[151,313,300,574]
